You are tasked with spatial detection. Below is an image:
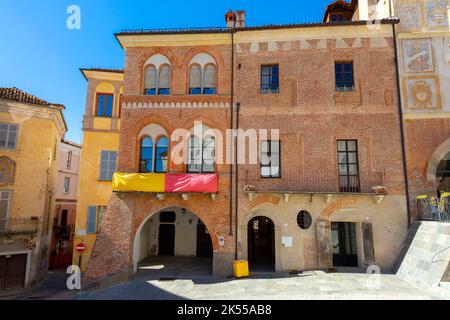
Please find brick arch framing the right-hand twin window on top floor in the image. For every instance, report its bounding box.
[179,46,225,94]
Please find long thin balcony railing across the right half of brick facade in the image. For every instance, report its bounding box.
[243,168,386,193]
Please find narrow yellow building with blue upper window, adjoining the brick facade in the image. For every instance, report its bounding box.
[73,69,123,271]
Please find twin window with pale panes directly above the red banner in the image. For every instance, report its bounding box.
[188,136,216,173]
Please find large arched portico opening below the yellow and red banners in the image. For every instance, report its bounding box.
[133,207,213,276]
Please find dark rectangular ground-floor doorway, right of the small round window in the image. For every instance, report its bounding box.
[331,222,358,267]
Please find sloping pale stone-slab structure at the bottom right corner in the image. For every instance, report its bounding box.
[396,221,450,299]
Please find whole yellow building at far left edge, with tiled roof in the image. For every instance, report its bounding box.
[0,88,67,292]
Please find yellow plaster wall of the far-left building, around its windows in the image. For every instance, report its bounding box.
[0,101,66,281]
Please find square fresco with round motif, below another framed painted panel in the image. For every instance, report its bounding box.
[404,76,441,109]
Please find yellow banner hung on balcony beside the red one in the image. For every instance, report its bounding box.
[113,173,165,192]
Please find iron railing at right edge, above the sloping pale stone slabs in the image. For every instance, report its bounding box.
[417,196,450,222]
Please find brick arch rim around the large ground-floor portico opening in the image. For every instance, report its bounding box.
[131,203,219,272]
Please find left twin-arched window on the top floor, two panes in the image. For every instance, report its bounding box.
[144,64,172,96]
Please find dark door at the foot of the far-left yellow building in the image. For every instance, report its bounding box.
[0,254,27,290]
